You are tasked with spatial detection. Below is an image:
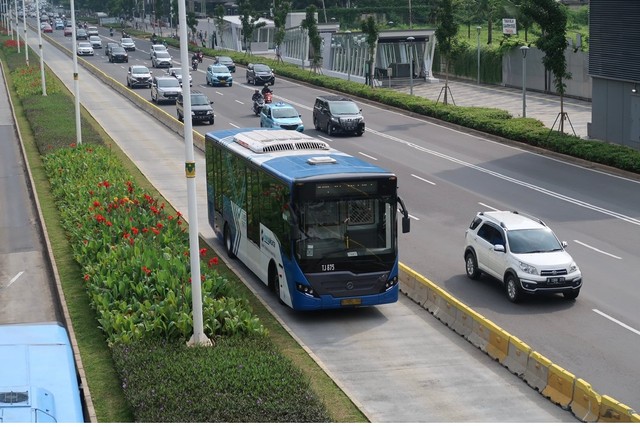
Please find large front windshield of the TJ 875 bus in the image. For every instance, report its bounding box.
[296,197,395,261]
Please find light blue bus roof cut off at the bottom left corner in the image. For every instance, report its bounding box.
[0,322,85,423]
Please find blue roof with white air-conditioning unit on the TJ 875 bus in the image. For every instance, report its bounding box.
[207,128,393,181]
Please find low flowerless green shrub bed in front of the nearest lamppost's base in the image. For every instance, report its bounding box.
[113,336,331,423]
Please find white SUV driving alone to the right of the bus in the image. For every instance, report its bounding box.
[464,211,582,303]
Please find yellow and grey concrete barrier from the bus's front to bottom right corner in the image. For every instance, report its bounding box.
[400,264,640,423]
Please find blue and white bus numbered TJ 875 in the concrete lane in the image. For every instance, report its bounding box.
[205,128,409,310]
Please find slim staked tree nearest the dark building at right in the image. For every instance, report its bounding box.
[522,0,571,132]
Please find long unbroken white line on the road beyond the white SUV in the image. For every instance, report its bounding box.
[369,129,640,226]
